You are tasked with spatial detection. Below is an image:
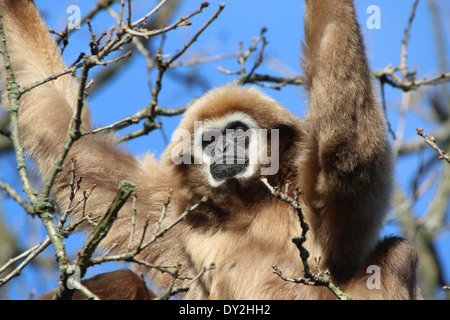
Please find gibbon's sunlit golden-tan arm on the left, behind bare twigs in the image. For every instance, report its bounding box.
[0,0,183,278]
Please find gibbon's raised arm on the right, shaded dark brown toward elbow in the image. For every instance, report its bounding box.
[300,0,392,281]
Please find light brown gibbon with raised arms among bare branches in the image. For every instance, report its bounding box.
[0,0,420,299]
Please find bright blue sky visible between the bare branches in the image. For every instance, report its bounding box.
[0,0,450,298]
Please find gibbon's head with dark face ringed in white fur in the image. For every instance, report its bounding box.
[165,85,299,188]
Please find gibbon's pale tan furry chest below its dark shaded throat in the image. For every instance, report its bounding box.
[185,207,302,299]
